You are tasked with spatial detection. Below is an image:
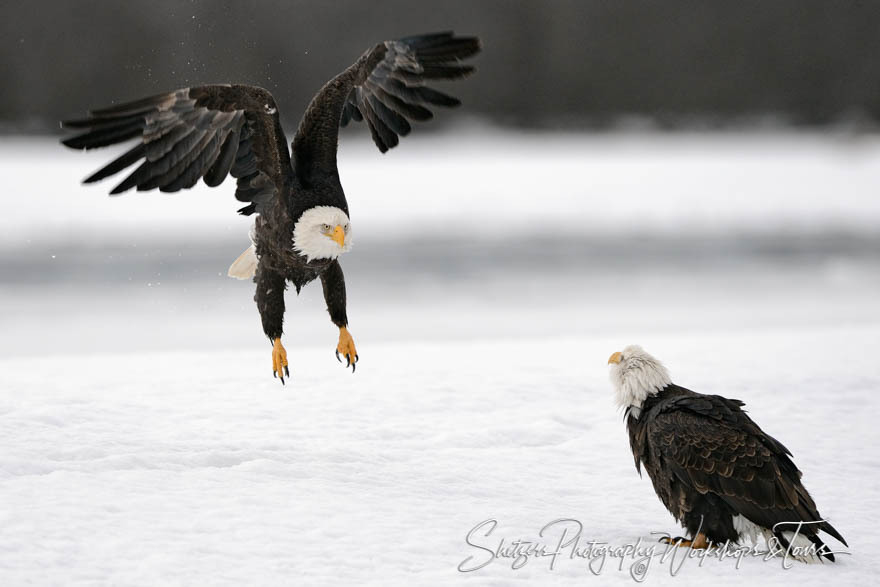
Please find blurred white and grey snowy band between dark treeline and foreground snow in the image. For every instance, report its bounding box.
[0,130,880,358]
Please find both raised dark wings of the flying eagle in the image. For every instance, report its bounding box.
[62,32,480,214]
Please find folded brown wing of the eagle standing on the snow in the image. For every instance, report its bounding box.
[647,395,845,544]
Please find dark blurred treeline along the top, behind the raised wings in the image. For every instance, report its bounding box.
[0,0,880,132]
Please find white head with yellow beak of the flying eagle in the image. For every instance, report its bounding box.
[293,206,354,261]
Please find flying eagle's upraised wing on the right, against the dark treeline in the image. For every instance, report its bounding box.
[293,32,480,181]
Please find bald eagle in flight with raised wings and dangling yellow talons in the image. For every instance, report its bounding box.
[62,32,480,383]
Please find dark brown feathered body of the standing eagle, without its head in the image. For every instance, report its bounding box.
[627,384,846,560]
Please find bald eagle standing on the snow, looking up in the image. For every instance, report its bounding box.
[608,345,846,562]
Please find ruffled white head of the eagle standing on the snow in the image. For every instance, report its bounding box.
[608,344,672,417]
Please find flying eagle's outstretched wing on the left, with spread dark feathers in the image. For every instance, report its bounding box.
[62,85,291,214]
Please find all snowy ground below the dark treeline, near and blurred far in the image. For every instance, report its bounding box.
[0,129,880,585]
